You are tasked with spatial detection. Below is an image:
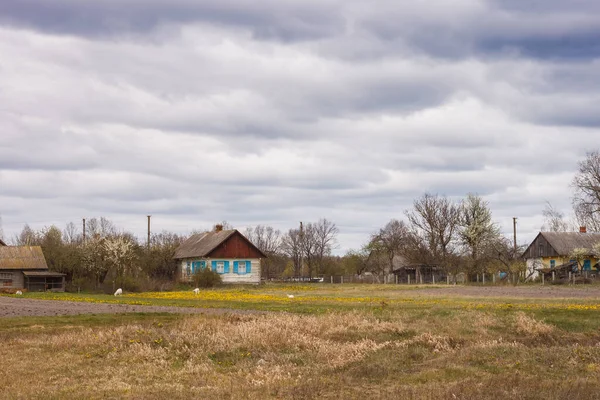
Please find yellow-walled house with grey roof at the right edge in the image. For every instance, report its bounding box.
[523,227,600,278]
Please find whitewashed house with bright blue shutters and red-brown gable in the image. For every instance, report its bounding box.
[174,225,267,284]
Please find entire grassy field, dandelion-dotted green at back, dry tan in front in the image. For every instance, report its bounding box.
[0,285,600,399]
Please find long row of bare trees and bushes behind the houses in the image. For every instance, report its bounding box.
[2,152,600,289]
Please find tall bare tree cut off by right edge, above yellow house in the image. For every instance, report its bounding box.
[572,151,600,232]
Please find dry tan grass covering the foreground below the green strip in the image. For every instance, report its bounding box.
[0,310,600,399]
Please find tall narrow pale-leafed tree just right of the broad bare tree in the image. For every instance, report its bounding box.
[458,193,500,272]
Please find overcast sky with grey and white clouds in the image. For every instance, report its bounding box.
[0,0,600,254]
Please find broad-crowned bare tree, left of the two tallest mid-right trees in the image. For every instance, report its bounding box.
[406,193,460,267]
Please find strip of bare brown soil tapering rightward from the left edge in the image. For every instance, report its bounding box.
[0,296,260,317]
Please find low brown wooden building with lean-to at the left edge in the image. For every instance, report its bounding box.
[0,246,65,292]
